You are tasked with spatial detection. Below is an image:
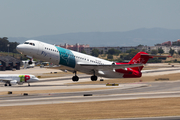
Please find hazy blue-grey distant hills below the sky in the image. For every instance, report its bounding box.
[8,28,180,47]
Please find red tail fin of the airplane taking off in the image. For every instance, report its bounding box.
[129,52,153,71]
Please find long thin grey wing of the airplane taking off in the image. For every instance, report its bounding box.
[79,64,143,69]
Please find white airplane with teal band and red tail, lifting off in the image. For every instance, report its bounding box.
[16,40,169,82]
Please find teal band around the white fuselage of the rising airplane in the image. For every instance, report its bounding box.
[56,46,76,68]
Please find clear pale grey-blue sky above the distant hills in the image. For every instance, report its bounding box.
[0,0,180,37]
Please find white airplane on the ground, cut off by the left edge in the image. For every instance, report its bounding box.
[0,74,39,86]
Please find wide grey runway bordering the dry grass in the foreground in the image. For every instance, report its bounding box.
[0,81,180,106]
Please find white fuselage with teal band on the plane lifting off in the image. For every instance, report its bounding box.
[17,40,123,78]
